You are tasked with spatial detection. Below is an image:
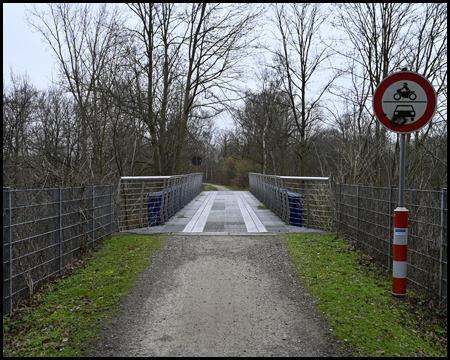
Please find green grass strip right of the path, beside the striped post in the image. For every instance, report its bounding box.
[286,234,447,356]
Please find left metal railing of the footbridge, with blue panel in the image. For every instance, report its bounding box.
[117,173,202,231]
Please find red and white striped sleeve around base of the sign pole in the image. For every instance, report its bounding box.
[392,207,408,296]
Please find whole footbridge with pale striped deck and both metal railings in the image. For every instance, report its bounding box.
[116,173,333,235]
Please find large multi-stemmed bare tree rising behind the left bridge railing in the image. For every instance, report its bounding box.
[128,4,257,174]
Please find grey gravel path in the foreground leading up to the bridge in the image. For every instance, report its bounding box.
[88,235,343,356]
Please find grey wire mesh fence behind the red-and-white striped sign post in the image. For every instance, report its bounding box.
[335,184,447,312]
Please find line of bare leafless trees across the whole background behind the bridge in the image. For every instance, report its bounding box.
[3,3,447,189]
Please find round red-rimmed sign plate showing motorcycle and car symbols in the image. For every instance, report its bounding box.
[373,71,437,133]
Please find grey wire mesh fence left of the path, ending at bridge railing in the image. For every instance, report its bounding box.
[3,185,114,315]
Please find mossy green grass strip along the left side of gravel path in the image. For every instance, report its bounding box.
[3,234,165,357]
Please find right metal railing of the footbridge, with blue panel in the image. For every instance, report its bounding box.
[248,173,333,230]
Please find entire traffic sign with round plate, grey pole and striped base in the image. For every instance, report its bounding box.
[373,69,437,296]
